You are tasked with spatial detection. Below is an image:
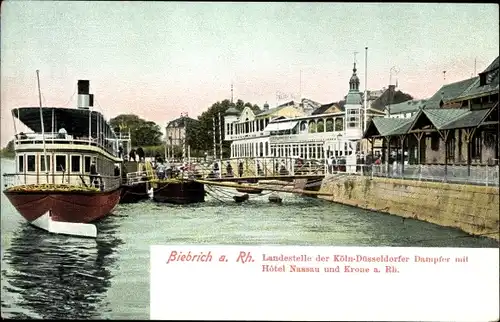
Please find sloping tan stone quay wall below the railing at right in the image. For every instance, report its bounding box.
[319,174,500,240]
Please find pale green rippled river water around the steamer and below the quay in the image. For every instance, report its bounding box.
[1,160,498,319]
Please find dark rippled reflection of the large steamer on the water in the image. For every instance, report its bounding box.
[2,219,122,319]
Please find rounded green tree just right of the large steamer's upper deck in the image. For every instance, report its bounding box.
[110,114,163,146]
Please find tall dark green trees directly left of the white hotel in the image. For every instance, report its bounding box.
[186,100,260,158]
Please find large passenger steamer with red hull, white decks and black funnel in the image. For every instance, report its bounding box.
[3,80,127,237]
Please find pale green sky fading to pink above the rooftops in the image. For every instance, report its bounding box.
[0,0,499,146]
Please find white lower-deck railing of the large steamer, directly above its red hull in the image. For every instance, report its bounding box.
[3,172,121,191]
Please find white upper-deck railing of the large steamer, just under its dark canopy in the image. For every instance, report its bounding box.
[14,132,118,157]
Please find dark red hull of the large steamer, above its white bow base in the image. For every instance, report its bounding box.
[4,189,121,223]
